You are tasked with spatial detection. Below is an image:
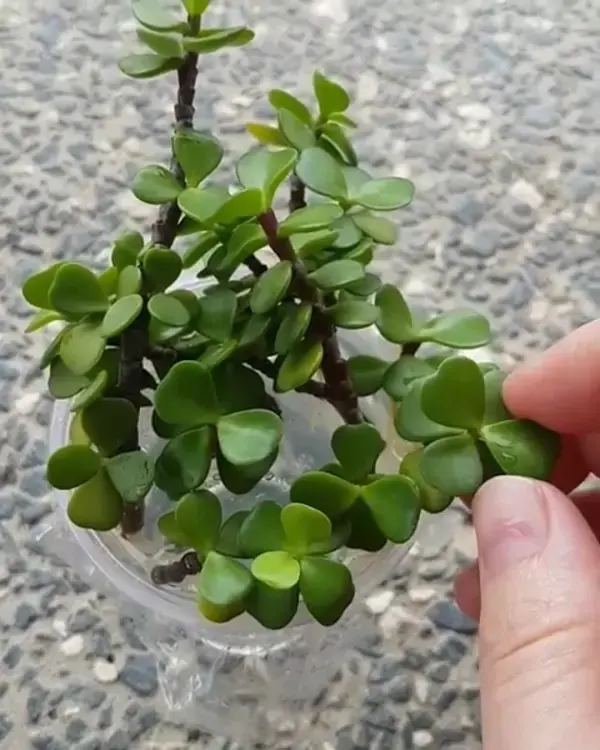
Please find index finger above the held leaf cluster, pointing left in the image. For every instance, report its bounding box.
[503,320,600,435]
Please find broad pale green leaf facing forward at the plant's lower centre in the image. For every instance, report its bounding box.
[217,409,283,466]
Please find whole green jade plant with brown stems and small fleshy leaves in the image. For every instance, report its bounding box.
[23,0,559,629]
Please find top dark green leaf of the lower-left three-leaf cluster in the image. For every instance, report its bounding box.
[81,398,137,456]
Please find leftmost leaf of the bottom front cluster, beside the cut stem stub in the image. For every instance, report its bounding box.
[196,551,254,623]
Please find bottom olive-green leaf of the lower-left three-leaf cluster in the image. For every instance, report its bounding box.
[67,470,123,531]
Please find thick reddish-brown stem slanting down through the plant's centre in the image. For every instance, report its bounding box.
[258,210,364,424]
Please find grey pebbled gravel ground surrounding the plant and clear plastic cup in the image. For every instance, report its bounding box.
[0,0,600,750]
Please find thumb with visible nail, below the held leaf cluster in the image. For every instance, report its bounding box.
[473,477,600,750]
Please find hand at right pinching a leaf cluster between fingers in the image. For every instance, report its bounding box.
[455,321,600,750]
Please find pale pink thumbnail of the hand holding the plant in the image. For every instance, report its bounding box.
[473,477,548,576]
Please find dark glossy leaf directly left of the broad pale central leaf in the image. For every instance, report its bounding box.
[154,425,213,499]
